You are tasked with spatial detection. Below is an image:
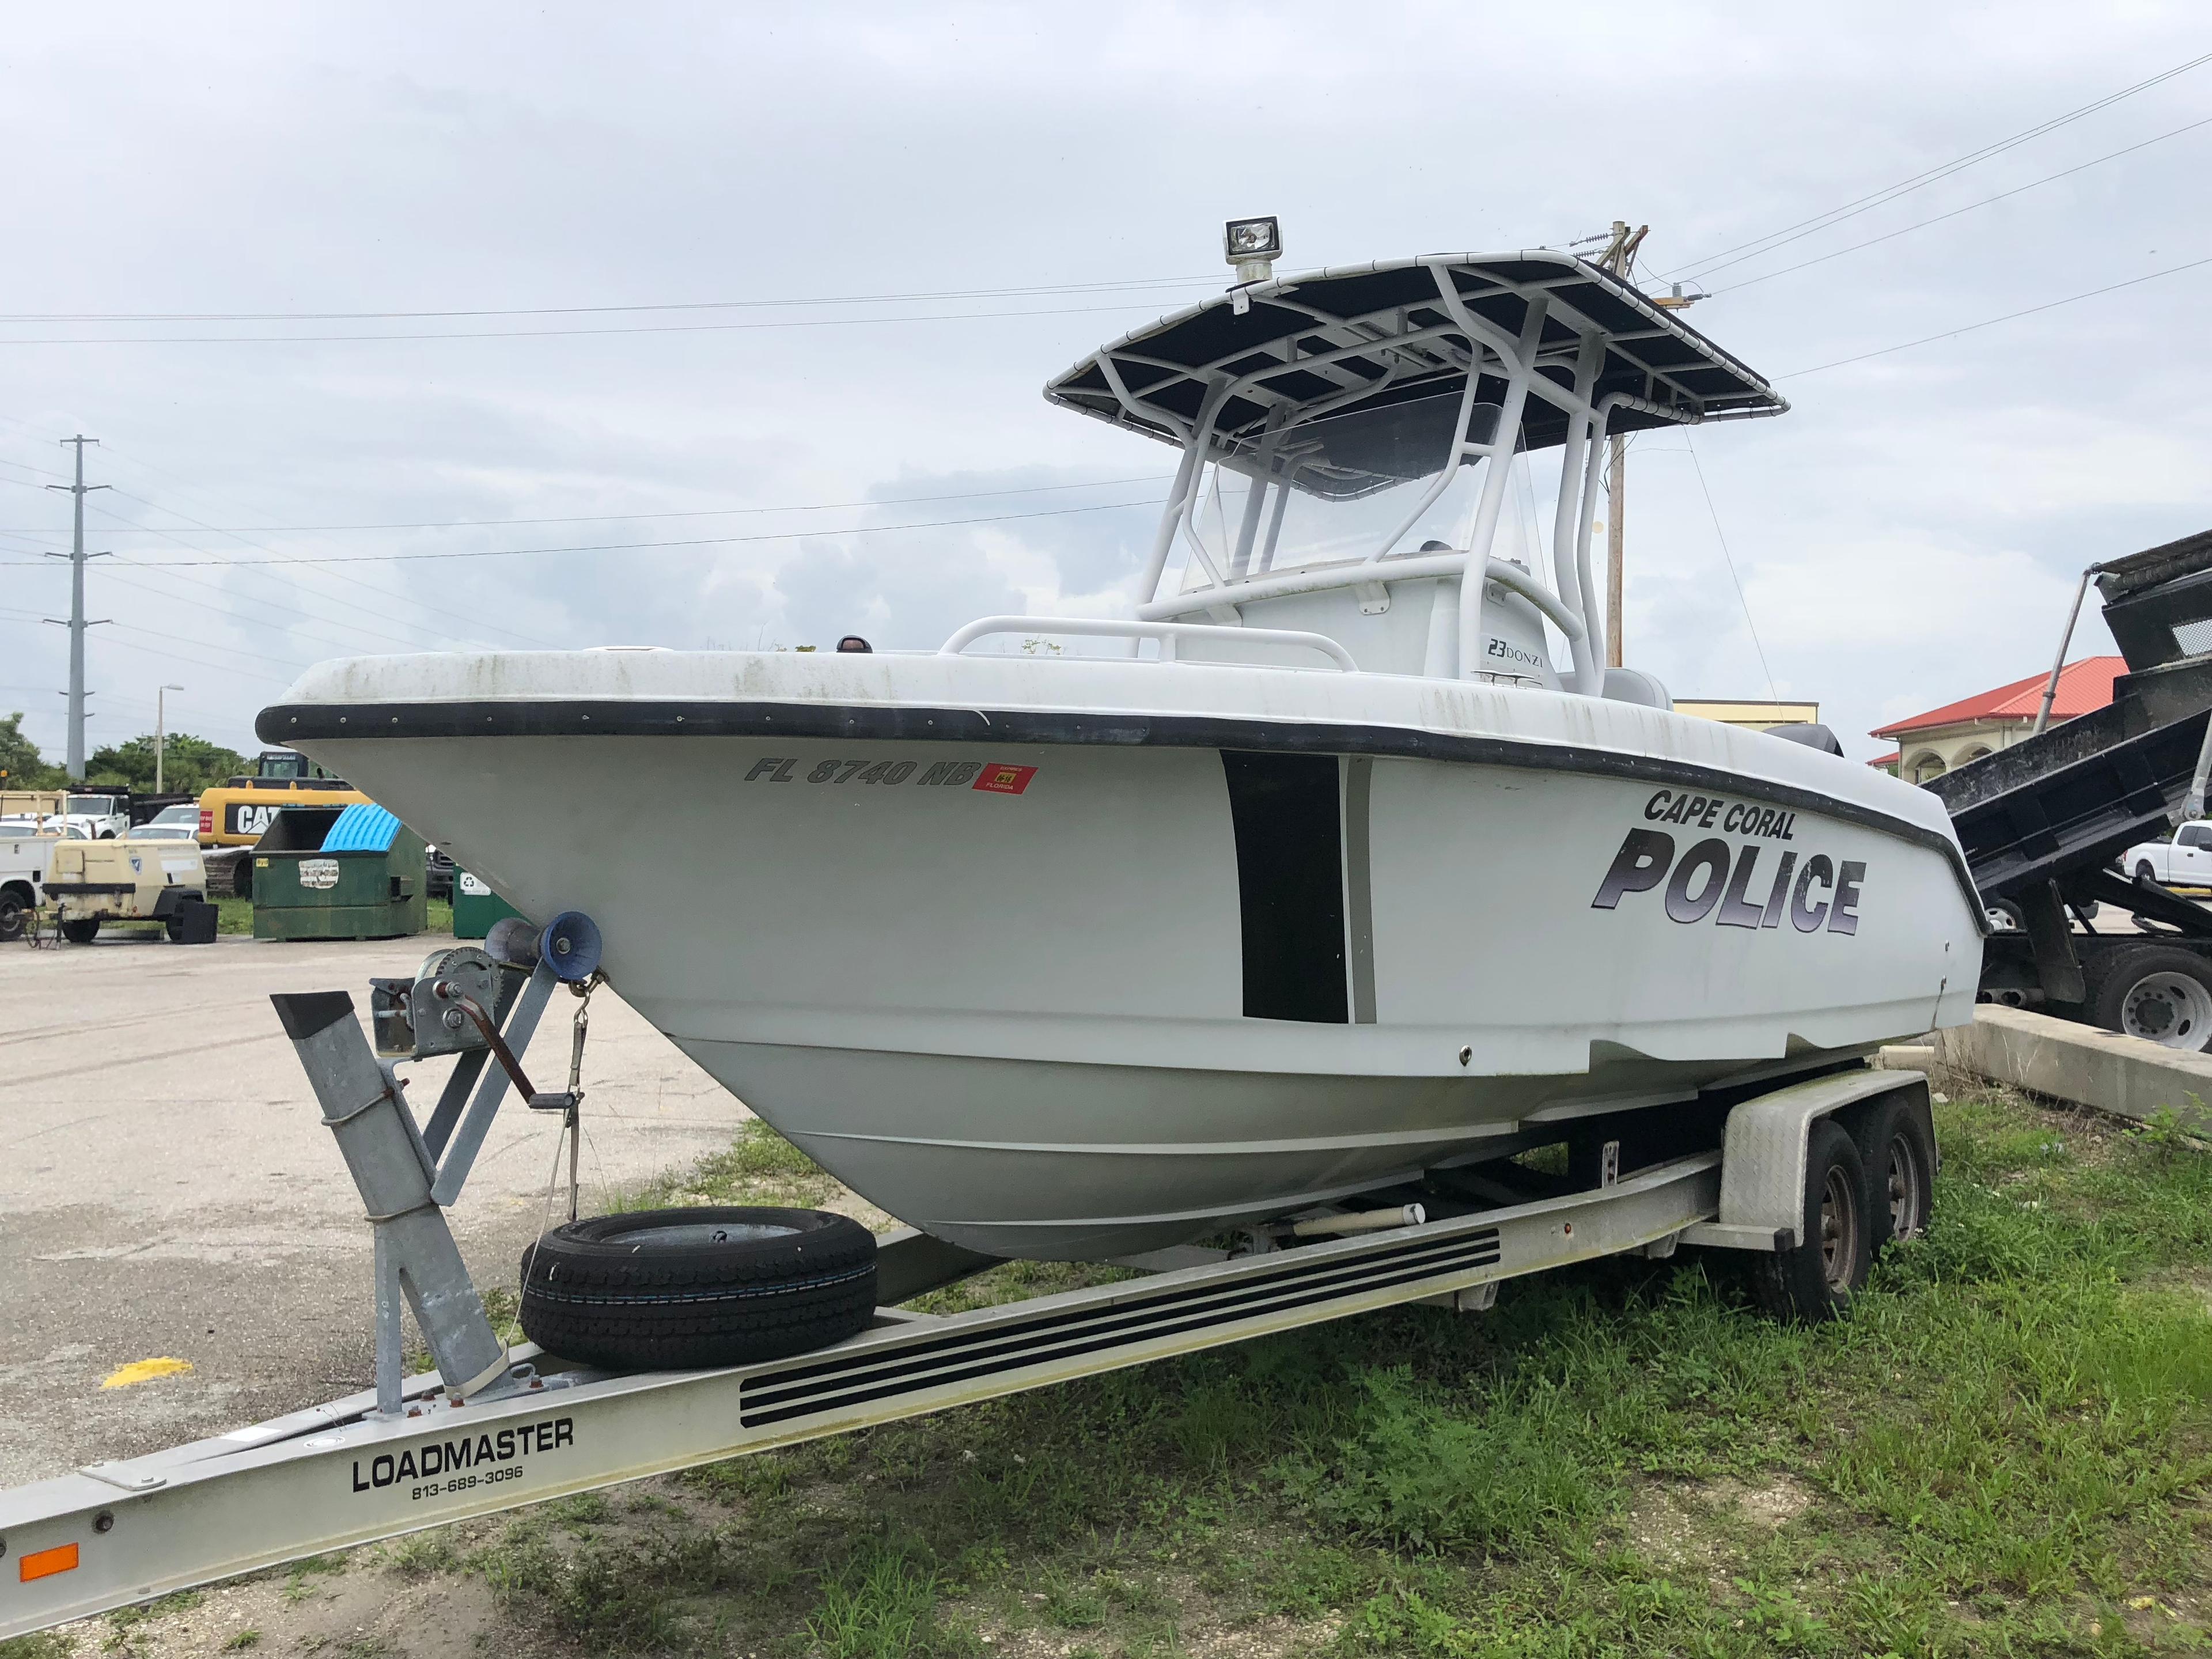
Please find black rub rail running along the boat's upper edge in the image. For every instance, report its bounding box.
[255,699,1988,933]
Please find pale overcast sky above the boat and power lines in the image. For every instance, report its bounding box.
[0,0,2212,756]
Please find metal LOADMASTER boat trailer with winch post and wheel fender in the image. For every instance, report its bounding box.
[0,916,1933,1637]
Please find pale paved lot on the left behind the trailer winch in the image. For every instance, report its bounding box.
[0,935,745,1486]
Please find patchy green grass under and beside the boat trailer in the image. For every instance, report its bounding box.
[39,1093,2212,1659]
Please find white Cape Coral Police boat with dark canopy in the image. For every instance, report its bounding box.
[256,228,1986,1259]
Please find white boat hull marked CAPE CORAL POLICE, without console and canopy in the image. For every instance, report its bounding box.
[263,659,1980,1259]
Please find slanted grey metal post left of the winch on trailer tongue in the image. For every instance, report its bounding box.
[270,991,509,1407]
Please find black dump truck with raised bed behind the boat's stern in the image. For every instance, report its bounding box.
[1927,531,2212,1048]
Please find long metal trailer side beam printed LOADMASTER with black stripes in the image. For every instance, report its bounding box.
[0,1153,1721,1637]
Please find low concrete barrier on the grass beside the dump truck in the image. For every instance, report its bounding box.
[1933,1002,2212,1130]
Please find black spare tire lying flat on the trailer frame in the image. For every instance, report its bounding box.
[522,1206,876,1372]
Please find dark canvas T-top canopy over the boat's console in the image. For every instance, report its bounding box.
[1044,250,1790,495]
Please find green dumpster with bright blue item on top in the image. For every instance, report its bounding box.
[255,801,429,938]
